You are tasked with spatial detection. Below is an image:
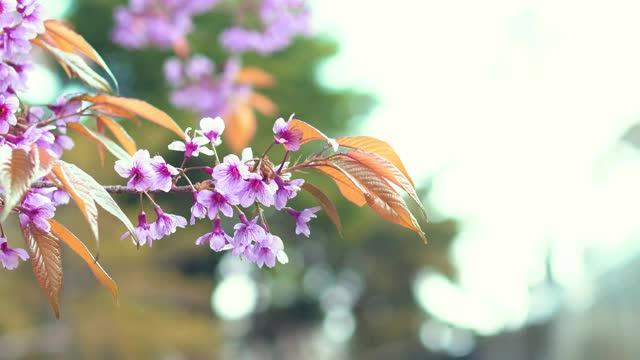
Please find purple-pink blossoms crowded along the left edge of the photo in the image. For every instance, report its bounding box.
[0,0,92,269]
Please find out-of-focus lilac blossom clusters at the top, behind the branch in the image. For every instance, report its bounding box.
[111,0,311,122]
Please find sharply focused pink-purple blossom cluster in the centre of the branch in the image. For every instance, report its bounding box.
[115,117,320,267]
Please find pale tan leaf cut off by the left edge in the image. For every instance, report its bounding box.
[0,146,38,221]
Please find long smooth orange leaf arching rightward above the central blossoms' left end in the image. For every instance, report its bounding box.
[77,94,185,139]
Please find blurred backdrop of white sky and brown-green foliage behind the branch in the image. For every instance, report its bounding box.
[0,0,640,360]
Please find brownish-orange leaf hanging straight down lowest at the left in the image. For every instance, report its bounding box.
[22,223,63,319]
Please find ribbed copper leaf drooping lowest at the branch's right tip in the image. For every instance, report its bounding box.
[332,157,427,243]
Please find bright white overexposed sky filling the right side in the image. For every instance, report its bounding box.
[313,0,640,333]
